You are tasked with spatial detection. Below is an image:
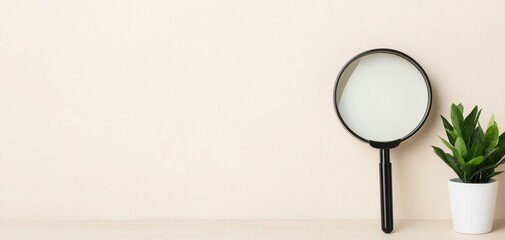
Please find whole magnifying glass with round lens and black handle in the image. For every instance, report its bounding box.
[333,48,431,233]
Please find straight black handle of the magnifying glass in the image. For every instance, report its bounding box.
[380,149,393,233]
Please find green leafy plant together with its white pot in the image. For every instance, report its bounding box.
[432,104,505,234]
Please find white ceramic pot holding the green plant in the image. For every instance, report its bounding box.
[449,178,498,234]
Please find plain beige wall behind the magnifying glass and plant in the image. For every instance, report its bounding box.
[0,0,505,219]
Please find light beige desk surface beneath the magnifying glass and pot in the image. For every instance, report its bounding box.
[0,220,505,240]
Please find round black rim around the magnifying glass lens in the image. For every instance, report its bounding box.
[333,48,432,148]
